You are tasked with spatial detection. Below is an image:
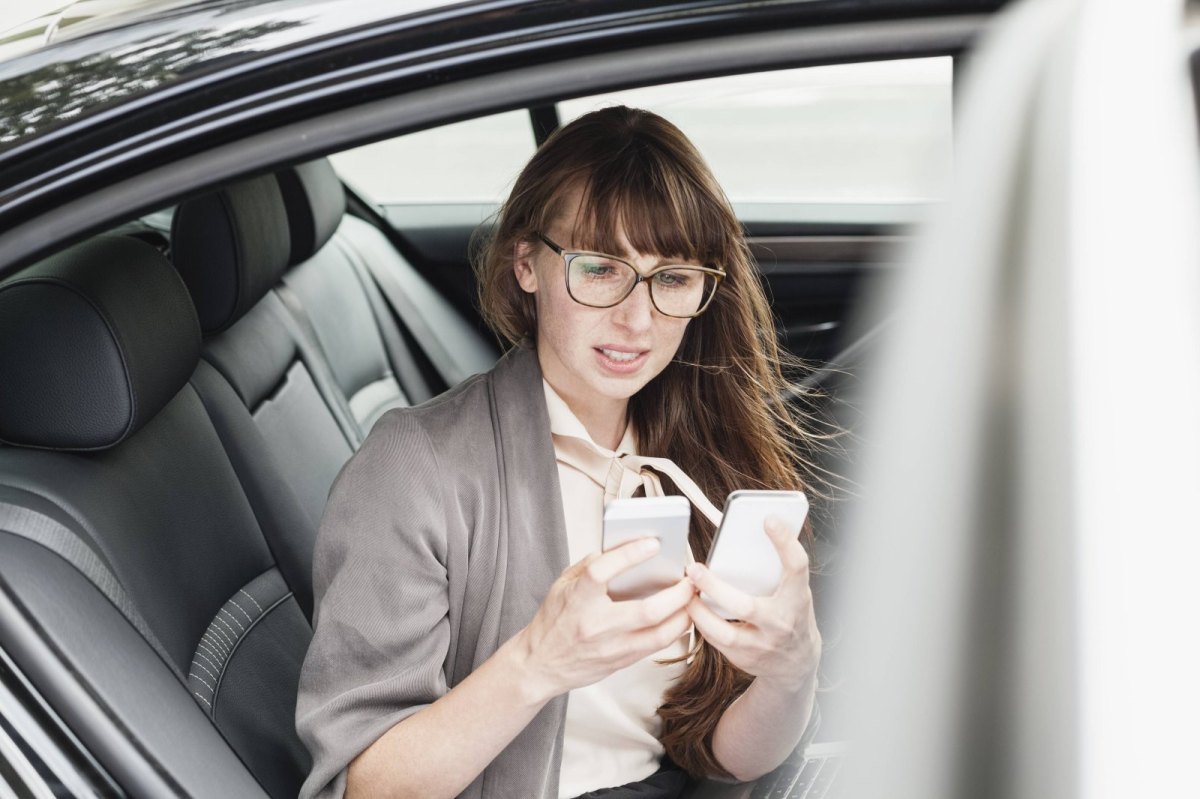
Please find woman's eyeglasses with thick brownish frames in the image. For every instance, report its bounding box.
[538,233,725,319]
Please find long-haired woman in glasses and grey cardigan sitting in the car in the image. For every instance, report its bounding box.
[298,108,821,799]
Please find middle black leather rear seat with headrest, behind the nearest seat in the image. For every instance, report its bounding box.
[172,176,362,618]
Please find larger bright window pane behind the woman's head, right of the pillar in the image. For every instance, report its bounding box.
[558,56,953,204]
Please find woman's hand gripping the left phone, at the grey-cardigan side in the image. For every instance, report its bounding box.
[518,539,696,699]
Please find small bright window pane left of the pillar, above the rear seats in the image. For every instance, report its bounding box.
[330,110,534,204]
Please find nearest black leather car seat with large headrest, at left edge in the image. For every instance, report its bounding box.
[0,236,311,797]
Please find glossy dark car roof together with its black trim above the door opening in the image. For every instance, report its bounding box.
[0,0,1006,273]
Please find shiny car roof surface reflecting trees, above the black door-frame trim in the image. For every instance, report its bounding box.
[0,0,1006,154]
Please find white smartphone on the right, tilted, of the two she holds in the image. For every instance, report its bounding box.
[700,491,809,619]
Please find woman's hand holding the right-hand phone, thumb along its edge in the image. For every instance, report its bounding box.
[688,517,821,692]
